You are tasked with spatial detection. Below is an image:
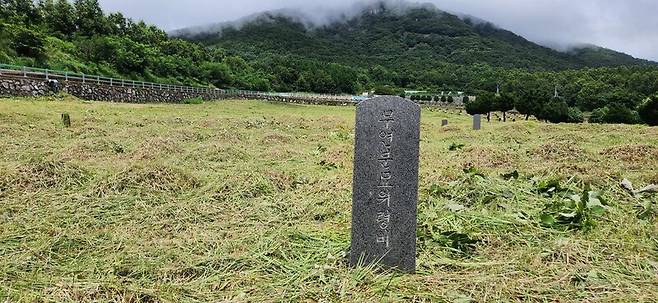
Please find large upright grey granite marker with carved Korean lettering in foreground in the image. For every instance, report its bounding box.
[350,97,420,272]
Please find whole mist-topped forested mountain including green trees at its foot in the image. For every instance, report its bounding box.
[174,2,658,123]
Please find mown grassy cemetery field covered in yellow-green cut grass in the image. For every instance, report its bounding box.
[0,97,658,302]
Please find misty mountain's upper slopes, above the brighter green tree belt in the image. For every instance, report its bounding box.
[181,3,652,71]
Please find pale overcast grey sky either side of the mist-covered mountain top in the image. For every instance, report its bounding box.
[100,0,658,61]
